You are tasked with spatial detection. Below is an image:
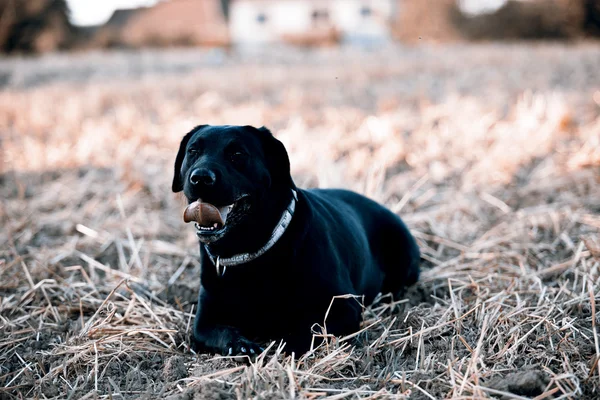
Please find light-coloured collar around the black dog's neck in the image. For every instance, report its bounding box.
[204,189,298,276]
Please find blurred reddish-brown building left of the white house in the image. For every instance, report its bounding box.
[95,0,229,47]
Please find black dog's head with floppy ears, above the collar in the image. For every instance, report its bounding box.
[172,125,294,243]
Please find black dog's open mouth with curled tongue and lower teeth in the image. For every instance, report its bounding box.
[183,196,245,235]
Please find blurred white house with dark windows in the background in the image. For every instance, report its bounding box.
[229,0,396,44]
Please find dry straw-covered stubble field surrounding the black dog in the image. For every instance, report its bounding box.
[0,43,600,400]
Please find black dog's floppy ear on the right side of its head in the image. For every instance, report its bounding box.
[253,126,295,188]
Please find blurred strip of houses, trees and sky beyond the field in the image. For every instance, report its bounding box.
[0,0,600,53]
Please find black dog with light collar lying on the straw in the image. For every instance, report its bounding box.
[173,125,420,355]
